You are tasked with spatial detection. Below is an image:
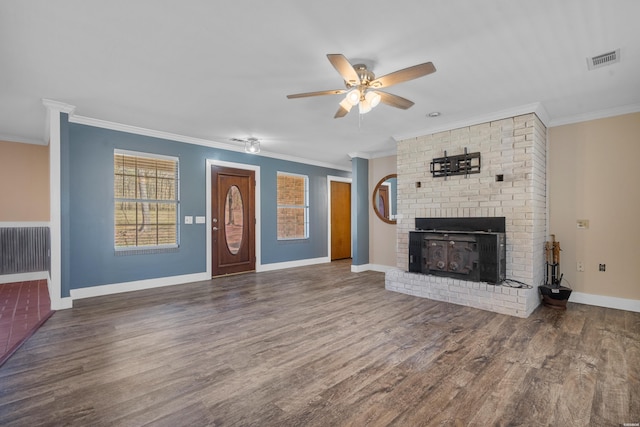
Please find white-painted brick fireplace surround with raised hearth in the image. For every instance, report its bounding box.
[385,113,547,317]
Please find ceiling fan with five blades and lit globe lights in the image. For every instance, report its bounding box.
[287,53,436,119]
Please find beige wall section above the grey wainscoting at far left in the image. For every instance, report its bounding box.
[0,141,49,222]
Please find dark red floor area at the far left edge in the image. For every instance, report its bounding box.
[0,280,53,365]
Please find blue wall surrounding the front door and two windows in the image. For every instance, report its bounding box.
[61,115,351,290]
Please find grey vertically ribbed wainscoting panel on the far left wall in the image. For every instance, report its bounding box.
[0,227,51,275]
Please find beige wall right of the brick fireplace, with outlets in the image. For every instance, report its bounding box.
[548,113,640,300]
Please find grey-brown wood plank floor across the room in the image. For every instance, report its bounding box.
[0,261,640,426]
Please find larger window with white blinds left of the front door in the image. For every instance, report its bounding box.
[113,150,179,251]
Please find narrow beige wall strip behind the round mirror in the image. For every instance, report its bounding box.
[369,156,396,267]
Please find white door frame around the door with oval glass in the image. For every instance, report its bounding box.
[206,159,262,277]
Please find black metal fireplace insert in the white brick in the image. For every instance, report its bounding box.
[409,218,506,284]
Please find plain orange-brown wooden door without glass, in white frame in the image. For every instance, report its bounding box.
[331,181,351,261]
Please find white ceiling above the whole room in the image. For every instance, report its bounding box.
[0,0,640,168]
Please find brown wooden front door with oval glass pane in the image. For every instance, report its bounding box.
[211,166,256,277]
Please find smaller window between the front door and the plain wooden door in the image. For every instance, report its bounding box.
[277,172,309,240]
